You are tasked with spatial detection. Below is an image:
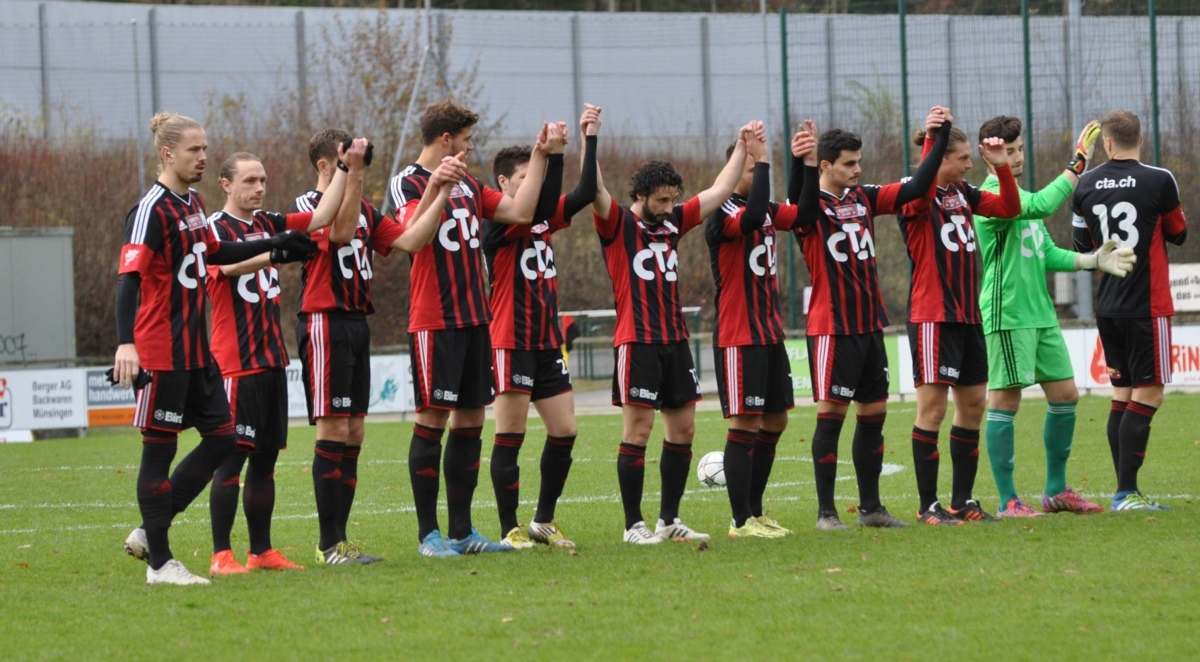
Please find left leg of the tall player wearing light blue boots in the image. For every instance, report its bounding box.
[408,331,461,556]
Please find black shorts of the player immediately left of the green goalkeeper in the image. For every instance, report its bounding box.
[908,321,988,386]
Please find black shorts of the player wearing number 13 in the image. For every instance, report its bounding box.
[1096,317,1171,386]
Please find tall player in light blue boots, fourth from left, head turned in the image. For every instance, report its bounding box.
[390,101,566,558]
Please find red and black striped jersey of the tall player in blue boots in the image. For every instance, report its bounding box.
[390,163,504,333]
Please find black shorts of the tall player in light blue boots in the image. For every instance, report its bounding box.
[408,325,496,411]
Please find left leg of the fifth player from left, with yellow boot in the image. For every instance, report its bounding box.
[490,349,534,549]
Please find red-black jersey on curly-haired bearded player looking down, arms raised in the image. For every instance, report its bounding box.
[592,198,702,347]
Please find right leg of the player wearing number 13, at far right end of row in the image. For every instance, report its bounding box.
[1112,317,1171,510]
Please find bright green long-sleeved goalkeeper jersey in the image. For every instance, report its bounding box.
[974,175,1079,333]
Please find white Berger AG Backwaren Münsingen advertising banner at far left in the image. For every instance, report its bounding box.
[0,368,88,432]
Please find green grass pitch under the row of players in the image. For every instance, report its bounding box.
[0,395,1200,660]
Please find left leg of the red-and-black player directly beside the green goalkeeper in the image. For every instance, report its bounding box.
[908,323,960,524]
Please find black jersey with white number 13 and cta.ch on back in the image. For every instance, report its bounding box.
[1070,160,1188,318]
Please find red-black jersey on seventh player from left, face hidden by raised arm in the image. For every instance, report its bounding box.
[704,193,797,347]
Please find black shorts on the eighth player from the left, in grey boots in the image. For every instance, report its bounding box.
[808,331,890,404]
